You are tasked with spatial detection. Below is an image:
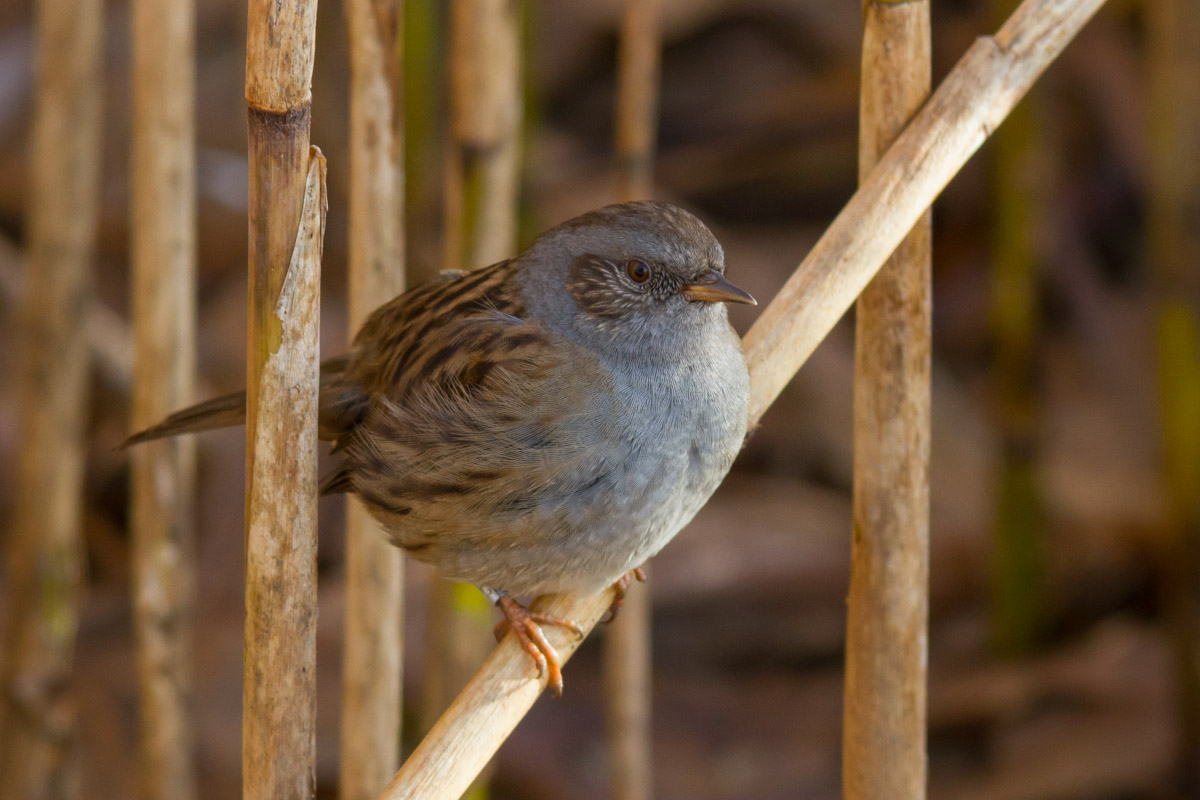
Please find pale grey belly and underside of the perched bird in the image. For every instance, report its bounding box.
[384,347,748,595]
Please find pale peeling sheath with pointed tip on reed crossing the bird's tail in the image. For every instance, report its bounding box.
[242,148,326,800]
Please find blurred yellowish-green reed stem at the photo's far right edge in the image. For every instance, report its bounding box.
[1146,0,1200,796]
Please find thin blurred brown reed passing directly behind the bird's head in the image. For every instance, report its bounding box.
[604,0,661,800]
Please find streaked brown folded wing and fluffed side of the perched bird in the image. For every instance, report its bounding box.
[344,264,611,572]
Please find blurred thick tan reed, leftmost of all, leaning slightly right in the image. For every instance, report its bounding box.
[0,0,103,800]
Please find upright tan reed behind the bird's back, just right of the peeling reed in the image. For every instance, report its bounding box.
[340,0,404,800]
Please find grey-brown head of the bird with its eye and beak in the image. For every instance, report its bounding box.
[520,201,755,359]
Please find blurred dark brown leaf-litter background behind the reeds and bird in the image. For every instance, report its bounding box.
[0,0,1200,800]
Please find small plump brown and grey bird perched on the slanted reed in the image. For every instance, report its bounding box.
[126,200,756,693]
